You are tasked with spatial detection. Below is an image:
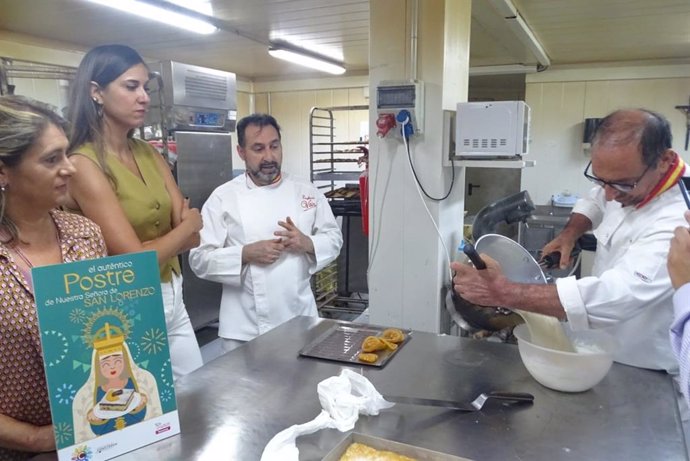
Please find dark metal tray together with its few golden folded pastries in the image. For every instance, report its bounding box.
[299,323,412,367]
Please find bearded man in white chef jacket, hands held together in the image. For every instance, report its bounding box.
[189,114,343,351]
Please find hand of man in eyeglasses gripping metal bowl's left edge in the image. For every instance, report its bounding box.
[450,254,510,307]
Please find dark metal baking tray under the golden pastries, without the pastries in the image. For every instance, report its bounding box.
[299,323,412,367]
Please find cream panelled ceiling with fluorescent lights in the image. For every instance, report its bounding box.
[0,0,690,81]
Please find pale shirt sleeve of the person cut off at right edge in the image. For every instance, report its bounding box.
[670,283,690,403]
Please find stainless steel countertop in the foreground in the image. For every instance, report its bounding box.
[105,317,687,461]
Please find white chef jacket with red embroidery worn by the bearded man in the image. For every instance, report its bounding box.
[189,173,343,341]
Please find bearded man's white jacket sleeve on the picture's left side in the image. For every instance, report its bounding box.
[189,192,244,286]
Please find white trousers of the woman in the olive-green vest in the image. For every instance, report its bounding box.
[161,273,203,380]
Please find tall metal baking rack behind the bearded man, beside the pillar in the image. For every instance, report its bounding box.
[309,105,369,316]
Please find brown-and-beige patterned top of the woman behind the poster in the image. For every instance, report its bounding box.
[0,210,107,461]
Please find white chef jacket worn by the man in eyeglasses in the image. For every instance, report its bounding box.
[556,186,686,373]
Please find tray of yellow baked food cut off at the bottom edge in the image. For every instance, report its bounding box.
[322,432,470,461]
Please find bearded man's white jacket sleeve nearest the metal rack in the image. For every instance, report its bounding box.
[309,190,343,274]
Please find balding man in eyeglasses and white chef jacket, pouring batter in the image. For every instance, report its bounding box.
[452,110,686,373]
